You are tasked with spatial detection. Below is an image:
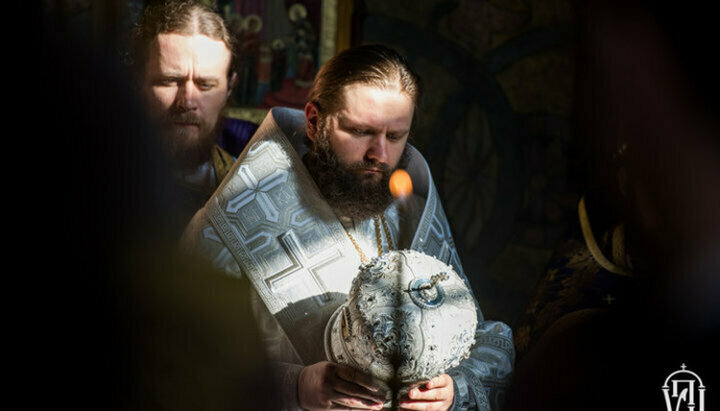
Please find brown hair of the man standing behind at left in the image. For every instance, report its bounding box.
[130,0,235,77]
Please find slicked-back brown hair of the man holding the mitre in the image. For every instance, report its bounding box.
[308,44,421,115]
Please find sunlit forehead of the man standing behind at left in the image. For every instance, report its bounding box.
[148,33,231,74]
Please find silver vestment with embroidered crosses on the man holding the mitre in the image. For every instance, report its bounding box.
[183,108,514,409]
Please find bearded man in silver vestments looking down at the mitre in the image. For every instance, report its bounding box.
[183,45,514,410]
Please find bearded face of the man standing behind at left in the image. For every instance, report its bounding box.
[143,33,231,167]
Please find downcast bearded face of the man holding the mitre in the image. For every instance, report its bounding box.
[305,84,414,218]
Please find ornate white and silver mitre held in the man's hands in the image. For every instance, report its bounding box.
[325,250,477,385]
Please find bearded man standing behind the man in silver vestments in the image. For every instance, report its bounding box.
[133,0,257,227]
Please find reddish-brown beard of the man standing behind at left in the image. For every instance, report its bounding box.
[161,111,221,170]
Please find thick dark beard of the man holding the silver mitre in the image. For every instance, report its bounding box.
[303,122,408,220]
